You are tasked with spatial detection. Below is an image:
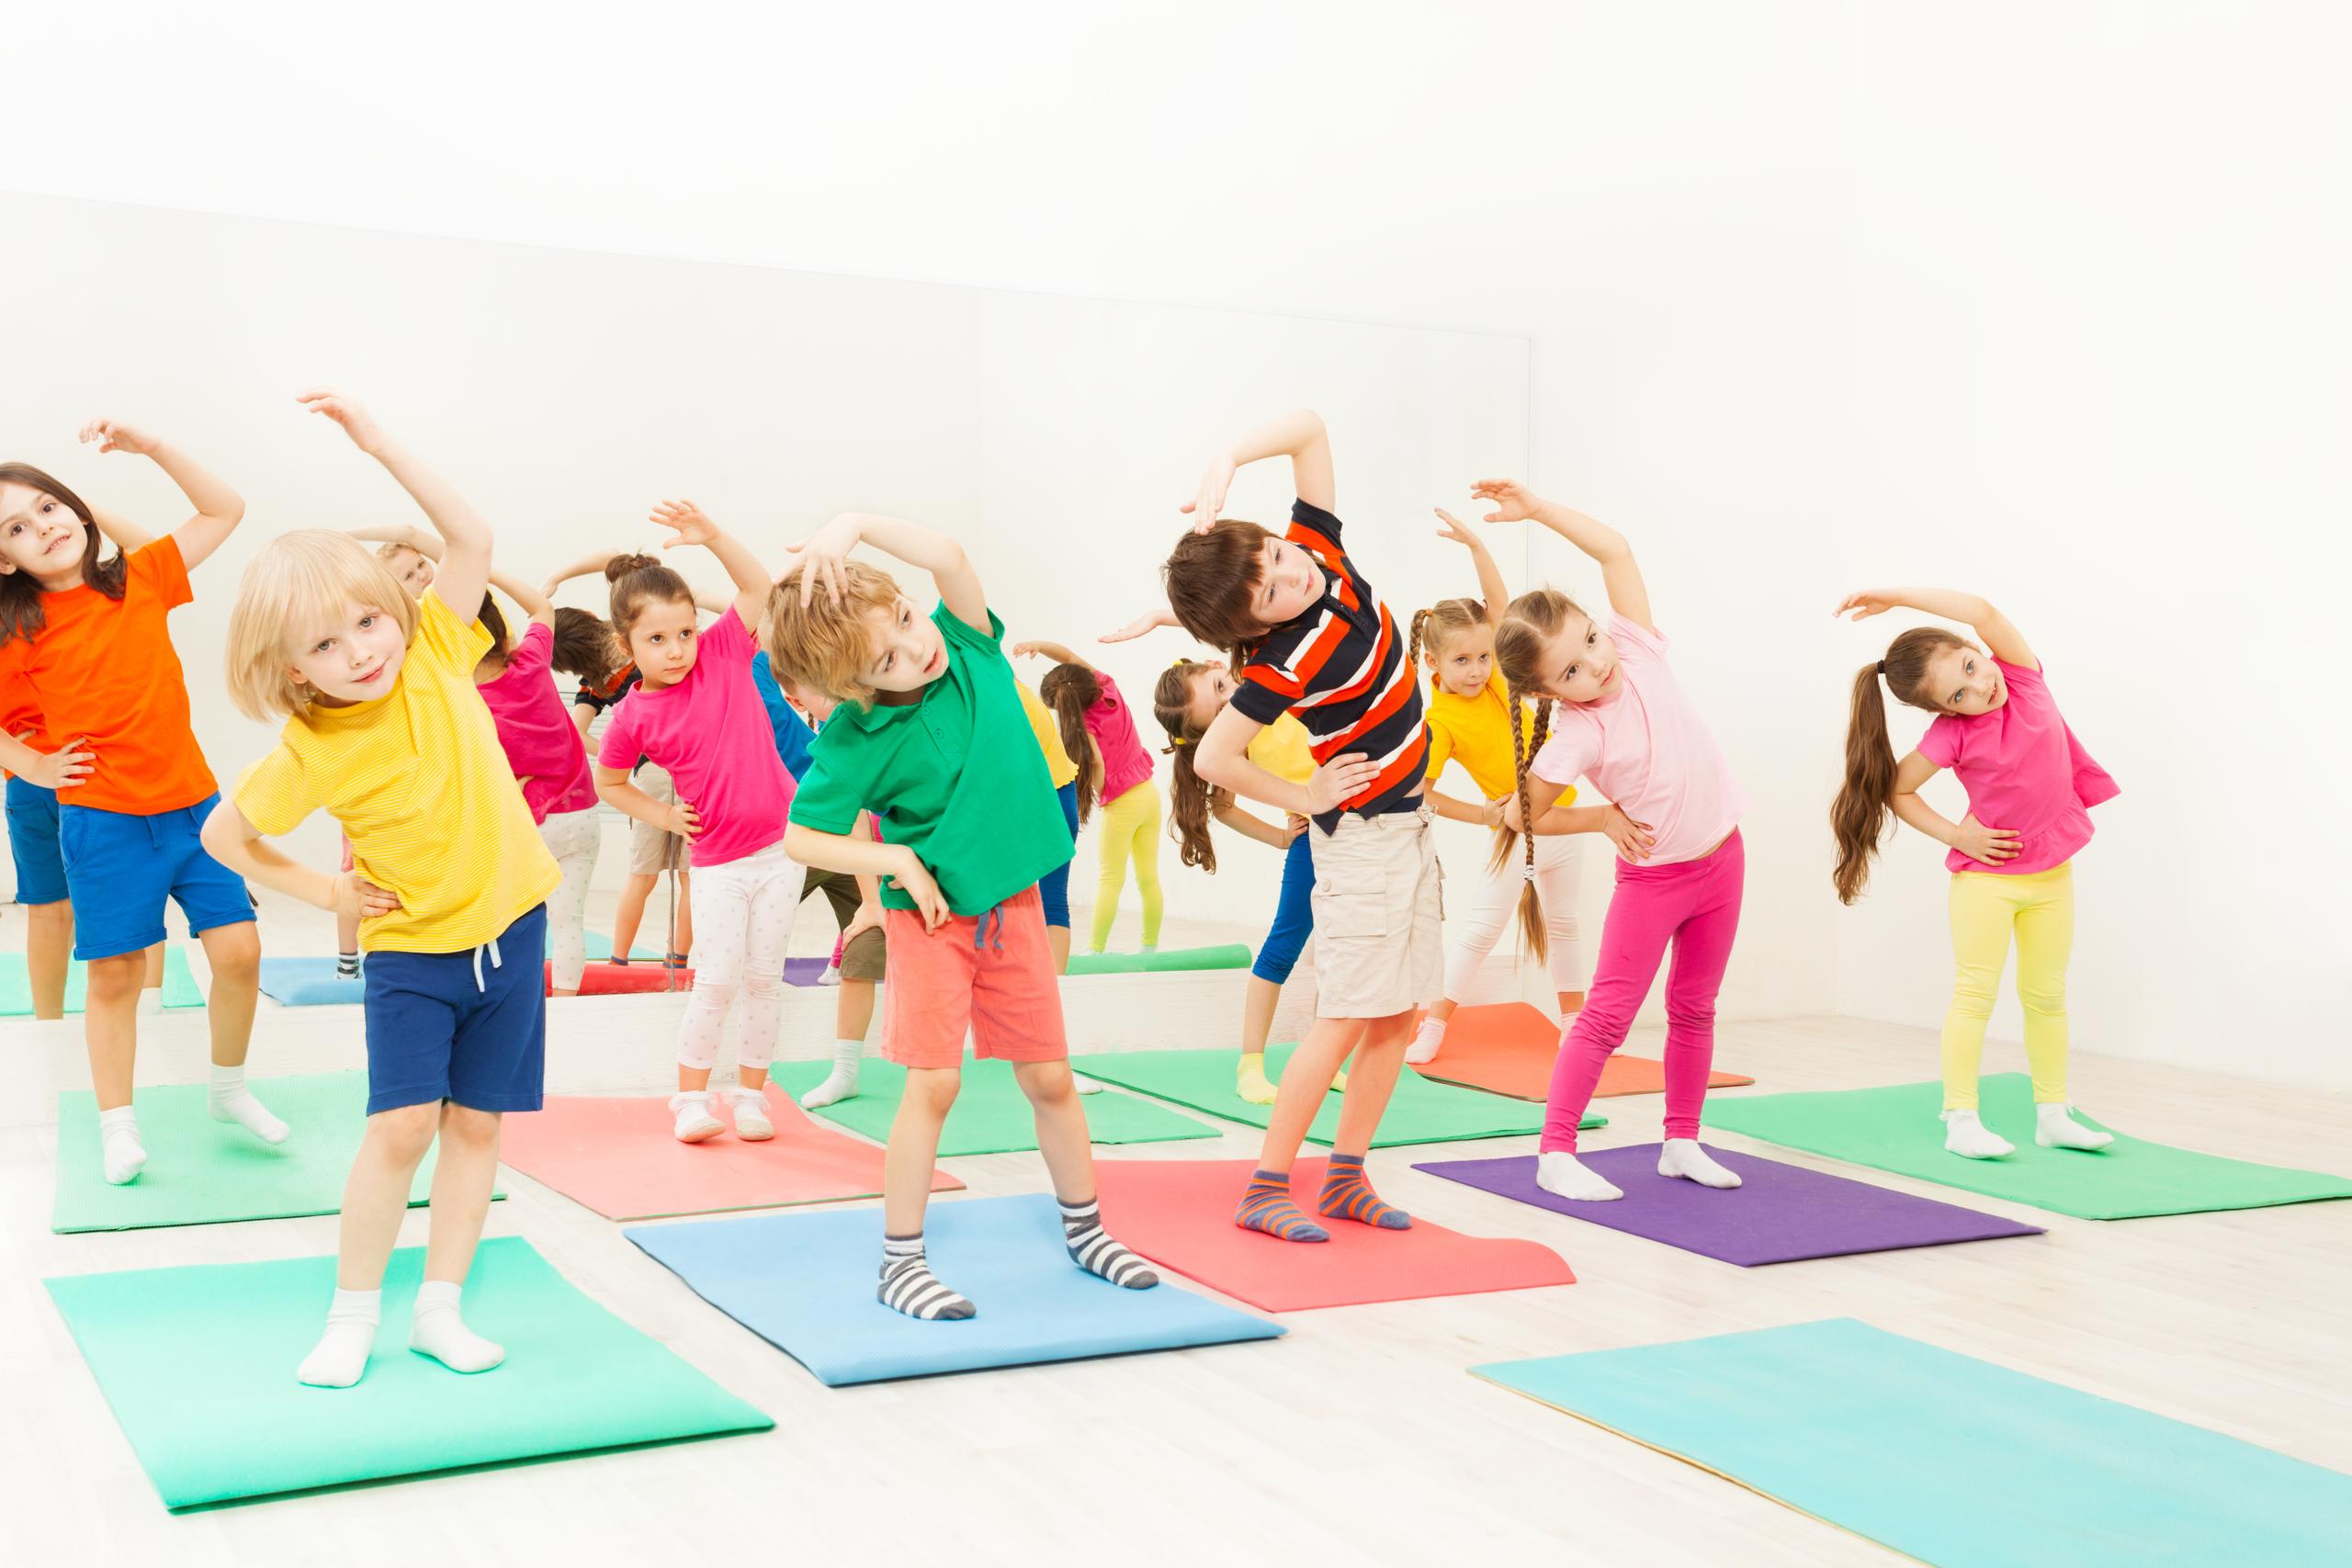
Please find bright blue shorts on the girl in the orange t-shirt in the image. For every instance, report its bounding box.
[56,795,254,962]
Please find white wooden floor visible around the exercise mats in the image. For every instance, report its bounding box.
[0,982,2352,1568]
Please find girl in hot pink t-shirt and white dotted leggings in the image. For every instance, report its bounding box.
[595,501,807,1143]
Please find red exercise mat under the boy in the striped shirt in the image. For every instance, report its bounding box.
[1093,1159,1576,1312]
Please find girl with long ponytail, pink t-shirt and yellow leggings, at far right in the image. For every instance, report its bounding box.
[1830,588,2117,1159]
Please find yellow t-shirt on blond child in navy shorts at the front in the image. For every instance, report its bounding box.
[235,588,562,949]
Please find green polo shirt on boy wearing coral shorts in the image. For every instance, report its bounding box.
[793,604,1072,915]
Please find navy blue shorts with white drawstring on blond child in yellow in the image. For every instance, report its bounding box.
[360,905,548,1117]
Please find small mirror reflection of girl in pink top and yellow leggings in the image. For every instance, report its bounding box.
[1013,642,1162,952]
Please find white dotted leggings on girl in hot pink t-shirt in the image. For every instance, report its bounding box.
[677,844,807,1072]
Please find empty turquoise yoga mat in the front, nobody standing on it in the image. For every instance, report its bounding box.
[1470,1319,2352,1568]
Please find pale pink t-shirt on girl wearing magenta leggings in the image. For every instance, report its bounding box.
[1529,616,1747,865]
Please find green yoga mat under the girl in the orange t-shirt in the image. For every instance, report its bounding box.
[50,1072,505,1232]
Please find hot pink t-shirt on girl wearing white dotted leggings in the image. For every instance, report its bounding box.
[595,604,793,865]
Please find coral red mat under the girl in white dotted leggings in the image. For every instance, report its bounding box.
[499,1086,965,1244]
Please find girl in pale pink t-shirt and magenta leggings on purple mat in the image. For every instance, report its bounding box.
[1473,479,1747,1201]
